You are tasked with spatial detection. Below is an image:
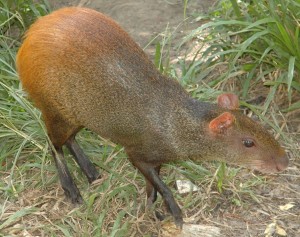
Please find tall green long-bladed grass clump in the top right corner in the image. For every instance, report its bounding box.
[183,0,300,112]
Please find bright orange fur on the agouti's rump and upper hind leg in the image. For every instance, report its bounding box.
[16,7,149,146]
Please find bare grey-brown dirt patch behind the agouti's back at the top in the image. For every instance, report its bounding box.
[49,0,215,55]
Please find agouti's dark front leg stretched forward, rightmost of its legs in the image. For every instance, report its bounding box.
[130,157,183,228]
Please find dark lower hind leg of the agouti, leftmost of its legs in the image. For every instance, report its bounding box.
[51,147,83,204]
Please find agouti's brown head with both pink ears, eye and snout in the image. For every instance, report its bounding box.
[204,94,288,173]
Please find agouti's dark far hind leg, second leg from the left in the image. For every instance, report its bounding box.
[65,135,100,183]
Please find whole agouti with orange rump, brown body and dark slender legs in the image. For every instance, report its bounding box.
[17,7,288,227]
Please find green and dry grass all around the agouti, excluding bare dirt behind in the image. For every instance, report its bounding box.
[0,0,300,237]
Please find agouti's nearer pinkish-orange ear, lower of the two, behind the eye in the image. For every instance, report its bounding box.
[209,112,235,133]
